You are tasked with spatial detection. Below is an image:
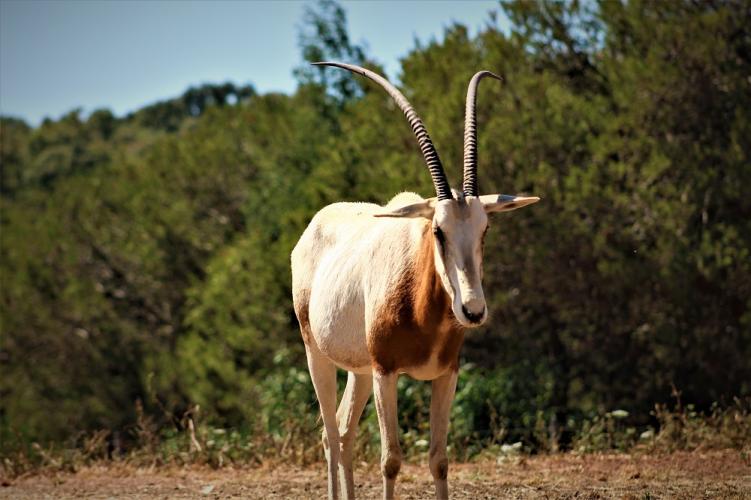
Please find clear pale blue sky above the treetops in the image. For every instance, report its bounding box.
[0,0,503,125]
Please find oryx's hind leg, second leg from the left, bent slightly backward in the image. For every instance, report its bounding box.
[336,372,373,500]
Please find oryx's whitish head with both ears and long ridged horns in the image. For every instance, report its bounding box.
[314,62,540,327]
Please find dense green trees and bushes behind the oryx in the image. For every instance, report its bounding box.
[0,0,751,454]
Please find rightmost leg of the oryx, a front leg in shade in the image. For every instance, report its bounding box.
[430,370,457,499]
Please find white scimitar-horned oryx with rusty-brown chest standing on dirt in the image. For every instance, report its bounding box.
[292,62,539,498]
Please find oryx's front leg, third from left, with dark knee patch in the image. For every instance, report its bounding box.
[373,370,402,500]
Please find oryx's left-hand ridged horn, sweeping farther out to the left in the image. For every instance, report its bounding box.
[313,62,453,200]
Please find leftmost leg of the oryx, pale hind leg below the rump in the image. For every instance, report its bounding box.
[305,345,339,500]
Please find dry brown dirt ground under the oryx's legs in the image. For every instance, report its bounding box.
[0,451,751,500]
